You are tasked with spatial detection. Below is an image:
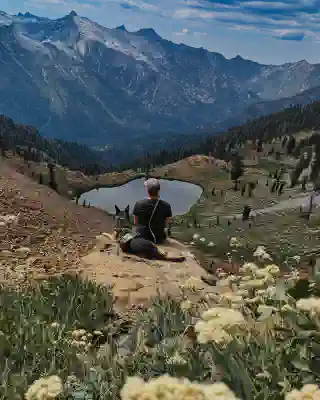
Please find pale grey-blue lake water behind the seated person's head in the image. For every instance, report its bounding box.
[79,178,202,215]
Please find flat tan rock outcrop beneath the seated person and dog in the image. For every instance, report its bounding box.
[81,235,219,308]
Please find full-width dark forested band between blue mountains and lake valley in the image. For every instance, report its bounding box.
[0,101,320,175]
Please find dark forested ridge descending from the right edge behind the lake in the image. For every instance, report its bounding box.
[119,101,320,169]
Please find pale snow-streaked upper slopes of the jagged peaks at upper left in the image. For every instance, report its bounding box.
[9,14,161,71]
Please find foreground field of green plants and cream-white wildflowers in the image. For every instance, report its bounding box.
[0,244,320,400]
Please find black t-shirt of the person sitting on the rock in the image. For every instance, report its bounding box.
[133,199,172,243]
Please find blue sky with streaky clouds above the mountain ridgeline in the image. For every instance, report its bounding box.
[0,0,320,64]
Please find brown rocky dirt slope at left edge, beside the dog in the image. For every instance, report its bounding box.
[0,161,112,281]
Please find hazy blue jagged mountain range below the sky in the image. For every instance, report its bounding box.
[0,12,320,146]
